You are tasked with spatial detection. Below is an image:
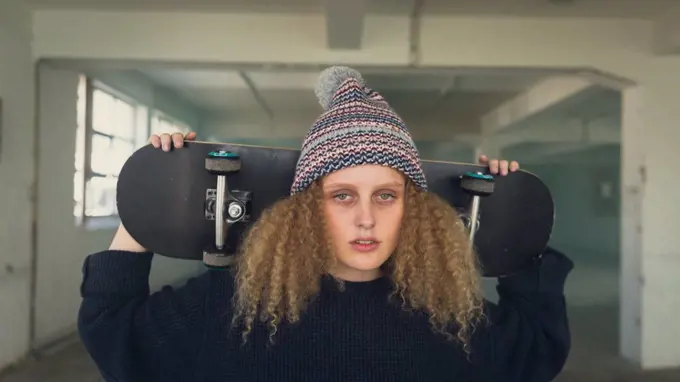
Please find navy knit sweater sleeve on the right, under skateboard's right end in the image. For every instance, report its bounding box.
[473,249,574,382]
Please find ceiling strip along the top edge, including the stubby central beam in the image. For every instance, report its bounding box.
[26,0,680,53]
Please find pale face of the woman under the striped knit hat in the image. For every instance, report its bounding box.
[322,165,406,281]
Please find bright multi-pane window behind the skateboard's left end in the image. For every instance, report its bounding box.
[73,76,189,228]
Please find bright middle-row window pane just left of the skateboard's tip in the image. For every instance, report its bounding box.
[91,134,135,175]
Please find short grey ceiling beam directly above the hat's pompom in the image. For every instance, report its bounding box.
[324,0,366,50]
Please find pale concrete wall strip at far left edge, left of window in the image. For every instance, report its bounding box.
[0,0,36,369]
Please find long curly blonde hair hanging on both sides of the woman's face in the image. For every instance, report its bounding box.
[234,181,483,351]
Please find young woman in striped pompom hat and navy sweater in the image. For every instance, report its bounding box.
[79,67,572,382]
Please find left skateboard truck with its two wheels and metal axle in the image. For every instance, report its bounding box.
[203,150,250,268]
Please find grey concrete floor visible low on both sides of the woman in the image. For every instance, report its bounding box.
[0,305,680,382]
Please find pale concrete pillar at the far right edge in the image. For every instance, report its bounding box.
[620,78,680,368]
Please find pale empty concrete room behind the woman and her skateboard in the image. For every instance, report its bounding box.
[0,0,680,382]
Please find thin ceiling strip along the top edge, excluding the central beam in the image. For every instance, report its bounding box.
[26,0,678,18]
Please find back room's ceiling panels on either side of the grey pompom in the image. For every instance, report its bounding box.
[137,67,544,119]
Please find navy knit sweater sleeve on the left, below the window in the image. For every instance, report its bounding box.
[78,250,209,382]
